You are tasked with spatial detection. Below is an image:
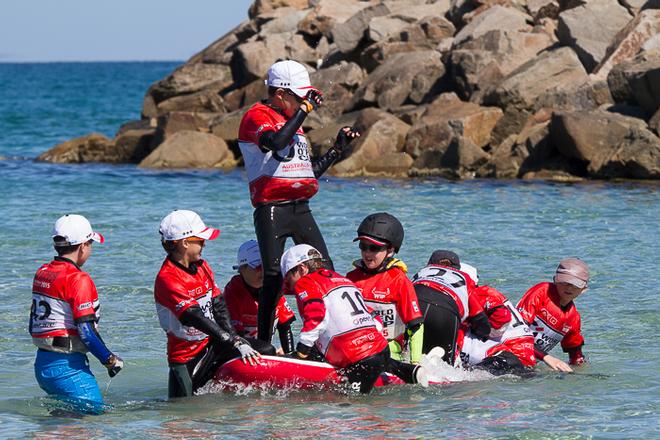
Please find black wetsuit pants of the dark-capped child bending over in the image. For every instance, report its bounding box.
[415,284,461,365]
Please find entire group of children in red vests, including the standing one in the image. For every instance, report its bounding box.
[30,60,589,410]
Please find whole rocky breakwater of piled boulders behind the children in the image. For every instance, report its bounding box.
[39,0,660,180]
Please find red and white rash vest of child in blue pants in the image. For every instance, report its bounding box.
[30,257,100,352]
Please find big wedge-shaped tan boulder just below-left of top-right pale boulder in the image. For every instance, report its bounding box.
[482,47,588,143]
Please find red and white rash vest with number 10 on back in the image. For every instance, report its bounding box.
[294,269,387,368]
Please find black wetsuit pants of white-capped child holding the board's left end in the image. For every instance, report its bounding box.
[167,338,275,398]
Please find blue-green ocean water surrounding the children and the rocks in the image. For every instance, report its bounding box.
[0,63,660,439]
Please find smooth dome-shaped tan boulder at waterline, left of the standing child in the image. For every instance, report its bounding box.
[139,131,236,169]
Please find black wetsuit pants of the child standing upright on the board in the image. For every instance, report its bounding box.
[254,200,332,342]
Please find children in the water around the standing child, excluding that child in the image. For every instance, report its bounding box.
[30,210,589,410]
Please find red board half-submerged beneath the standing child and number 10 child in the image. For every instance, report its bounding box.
[214,356,439,389]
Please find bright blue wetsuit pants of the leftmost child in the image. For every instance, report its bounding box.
[34,350,103,404]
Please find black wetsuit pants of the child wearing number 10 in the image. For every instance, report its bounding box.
[340,347,419,394]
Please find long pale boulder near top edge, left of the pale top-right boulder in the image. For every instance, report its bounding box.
[454,5,532,46]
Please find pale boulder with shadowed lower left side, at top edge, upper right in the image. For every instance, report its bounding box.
[557,0,632,72]
